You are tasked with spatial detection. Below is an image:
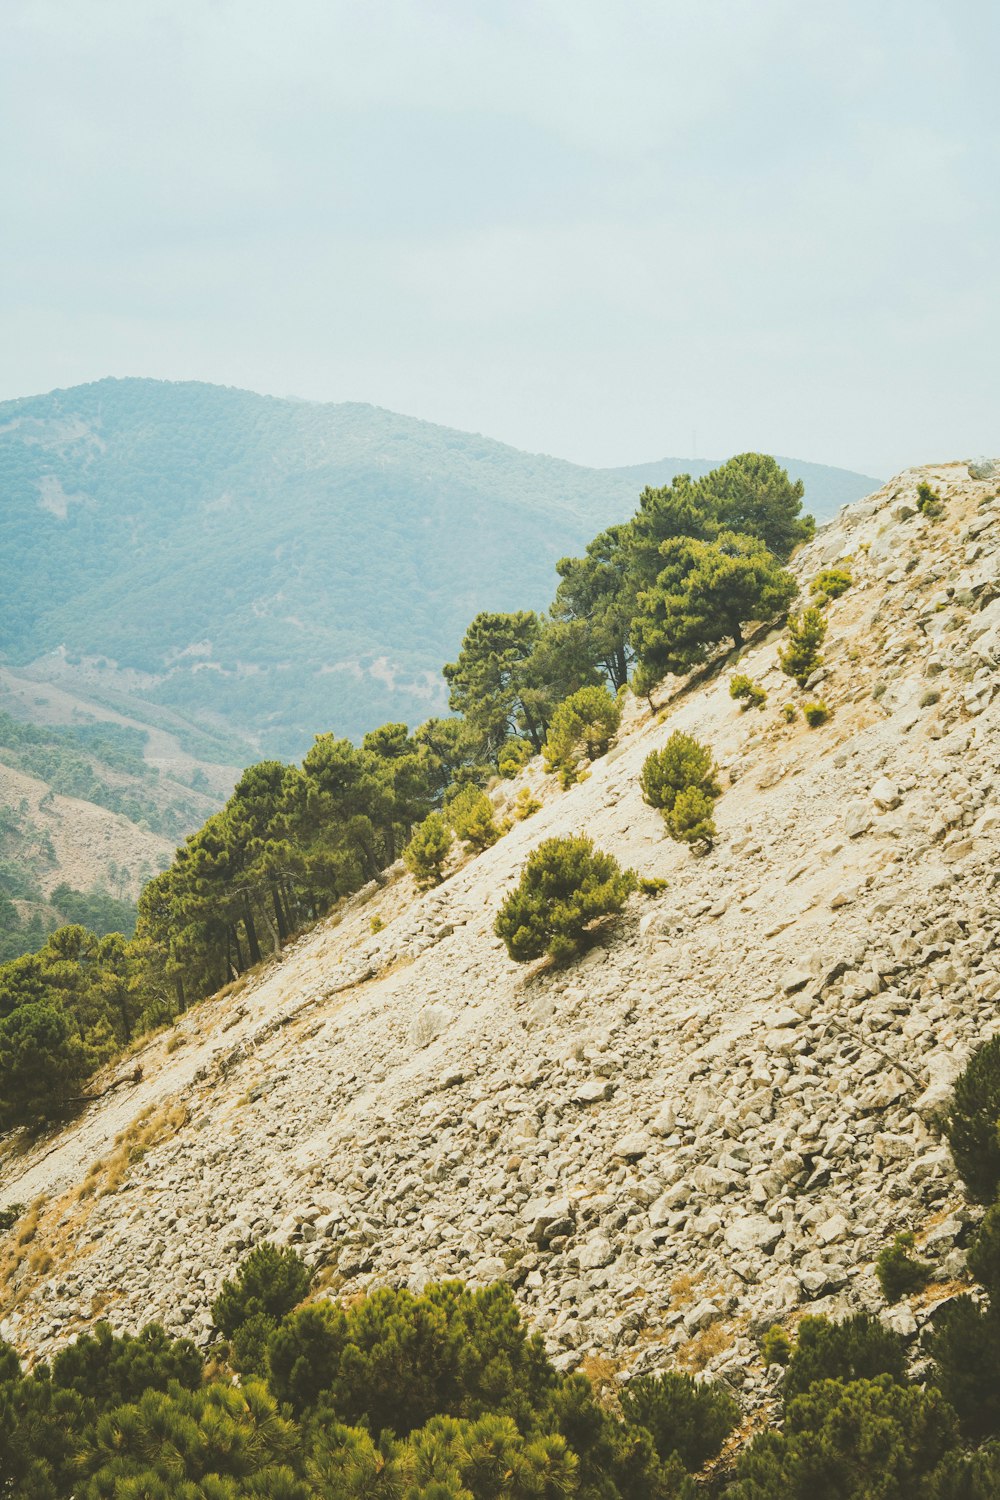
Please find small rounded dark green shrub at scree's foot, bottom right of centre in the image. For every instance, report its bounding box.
[621,1371,739,1470]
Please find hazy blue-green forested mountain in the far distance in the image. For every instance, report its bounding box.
[0,380,877,764]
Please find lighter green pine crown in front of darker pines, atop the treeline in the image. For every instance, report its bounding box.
[633,531,796,675]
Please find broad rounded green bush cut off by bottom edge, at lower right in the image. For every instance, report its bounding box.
[727,1376,957,1500]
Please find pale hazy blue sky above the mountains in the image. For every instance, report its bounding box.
[0,0,1000,476]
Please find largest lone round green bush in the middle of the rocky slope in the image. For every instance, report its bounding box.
[493,836,637,963]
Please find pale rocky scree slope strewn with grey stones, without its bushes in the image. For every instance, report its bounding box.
[0,464,1000,1406]
